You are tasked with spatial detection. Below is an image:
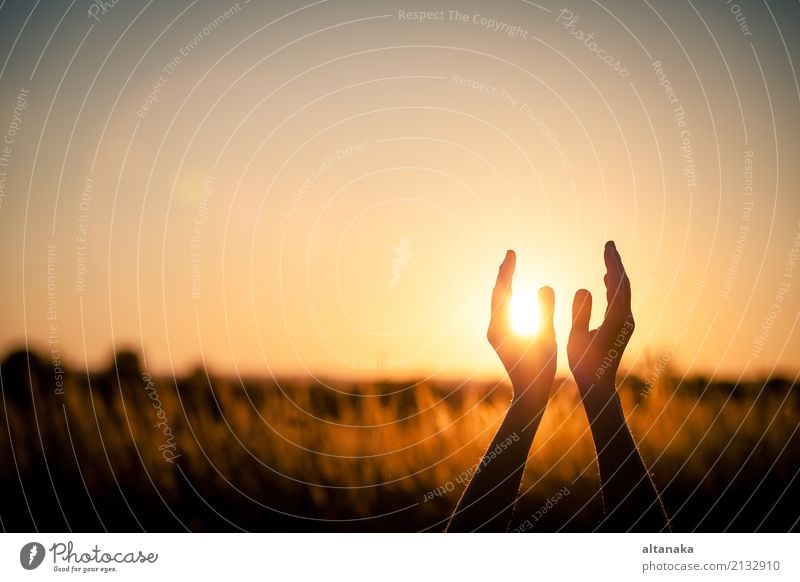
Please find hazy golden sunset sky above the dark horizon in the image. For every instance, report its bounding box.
[0,0,800,379]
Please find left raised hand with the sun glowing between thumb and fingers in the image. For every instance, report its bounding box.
[486,251,556,408]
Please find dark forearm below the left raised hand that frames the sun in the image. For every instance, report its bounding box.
[447,392,543,532]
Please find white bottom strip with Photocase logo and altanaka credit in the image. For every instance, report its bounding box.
[0,534,800,582]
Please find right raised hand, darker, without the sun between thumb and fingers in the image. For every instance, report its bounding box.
[567,241,634,398]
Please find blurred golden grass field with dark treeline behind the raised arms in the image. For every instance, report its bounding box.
[0,351,800,531]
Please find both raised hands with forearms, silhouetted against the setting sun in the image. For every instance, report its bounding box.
[448,241,669,531]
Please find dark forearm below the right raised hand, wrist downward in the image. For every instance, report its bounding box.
[581,382,669,531]
